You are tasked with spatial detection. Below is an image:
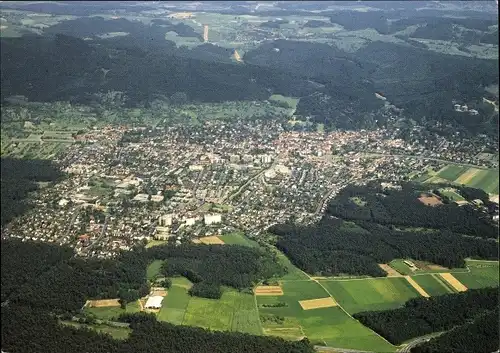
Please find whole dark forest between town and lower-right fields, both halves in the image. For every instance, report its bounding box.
[269,183,498,277]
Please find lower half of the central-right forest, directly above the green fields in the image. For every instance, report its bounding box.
[269,216,498,277]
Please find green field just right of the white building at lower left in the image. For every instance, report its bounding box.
[158,278,262,335]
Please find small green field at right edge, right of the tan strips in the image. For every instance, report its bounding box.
[453,260,500,289]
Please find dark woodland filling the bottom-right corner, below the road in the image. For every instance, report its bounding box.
[411,307,499,353]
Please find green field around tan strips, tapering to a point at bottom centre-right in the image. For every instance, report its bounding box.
[256,280,396,352]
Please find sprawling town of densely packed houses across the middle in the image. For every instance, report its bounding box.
[2,119,498,258]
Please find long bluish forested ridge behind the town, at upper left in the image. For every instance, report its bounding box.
[0,34,314,106]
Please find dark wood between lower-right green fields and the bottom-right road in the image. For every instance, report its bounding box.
[354,287,498,347]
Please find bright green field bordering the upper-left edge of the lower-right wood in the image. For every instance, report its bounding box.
[321,277,420,314]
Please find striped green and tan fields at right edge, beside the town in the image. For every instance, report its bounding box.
[418,165,499,195]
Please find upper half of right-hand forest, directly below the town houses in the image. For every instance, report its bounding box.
[326,183,498,239]
